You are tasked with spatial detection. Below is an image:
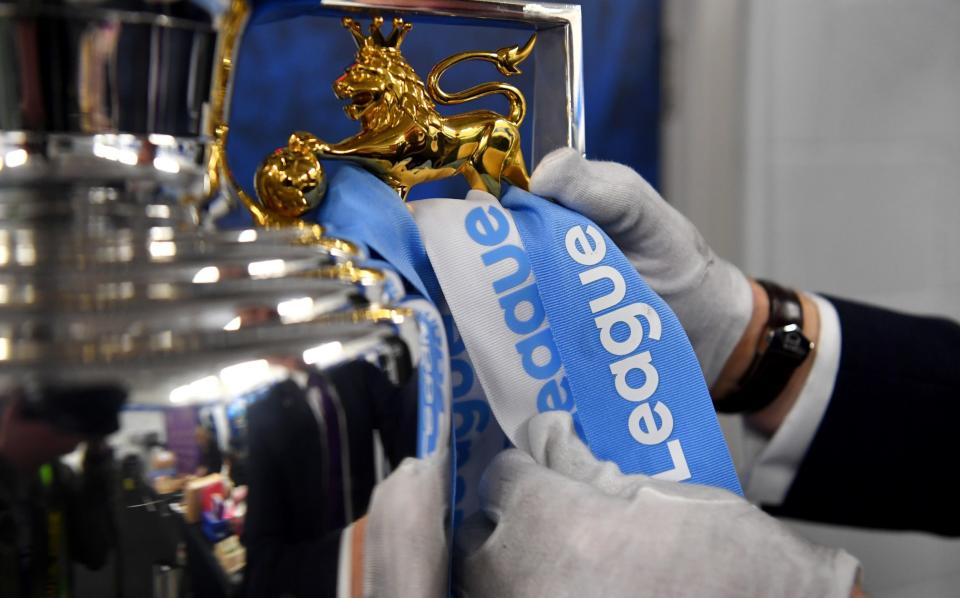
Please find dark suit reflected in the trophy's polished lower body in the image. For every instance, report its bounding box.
[243,345,418,597]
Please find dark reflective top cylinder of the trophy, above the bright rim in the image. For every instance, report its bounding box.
[0,0,215,136]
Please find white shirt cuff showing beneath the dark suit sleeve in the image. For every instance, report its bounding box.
[744,295,840,505]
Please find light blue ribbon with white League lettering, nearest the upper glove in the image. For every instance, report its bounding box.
[501,188,742,494]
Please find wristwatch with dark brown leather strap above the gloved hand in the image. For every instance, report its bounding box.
[714,280,813,413]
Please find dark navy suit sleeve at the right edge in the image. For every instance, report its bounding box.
[768,298,960,536]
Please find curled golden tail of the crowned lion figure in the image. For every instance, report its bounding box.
[427,33,537,126]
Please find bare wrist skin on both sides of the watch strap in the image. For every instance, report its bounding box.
[710,280,820,435]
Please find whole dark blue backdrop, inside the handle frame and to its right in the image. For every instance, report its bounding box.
[228,0,662,223]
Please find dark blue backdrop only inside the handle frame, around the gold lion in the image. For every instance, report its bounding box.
[228,16,535,209]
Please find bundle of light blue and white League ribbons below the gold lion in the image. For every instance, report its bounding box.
[319,167,741,514]
